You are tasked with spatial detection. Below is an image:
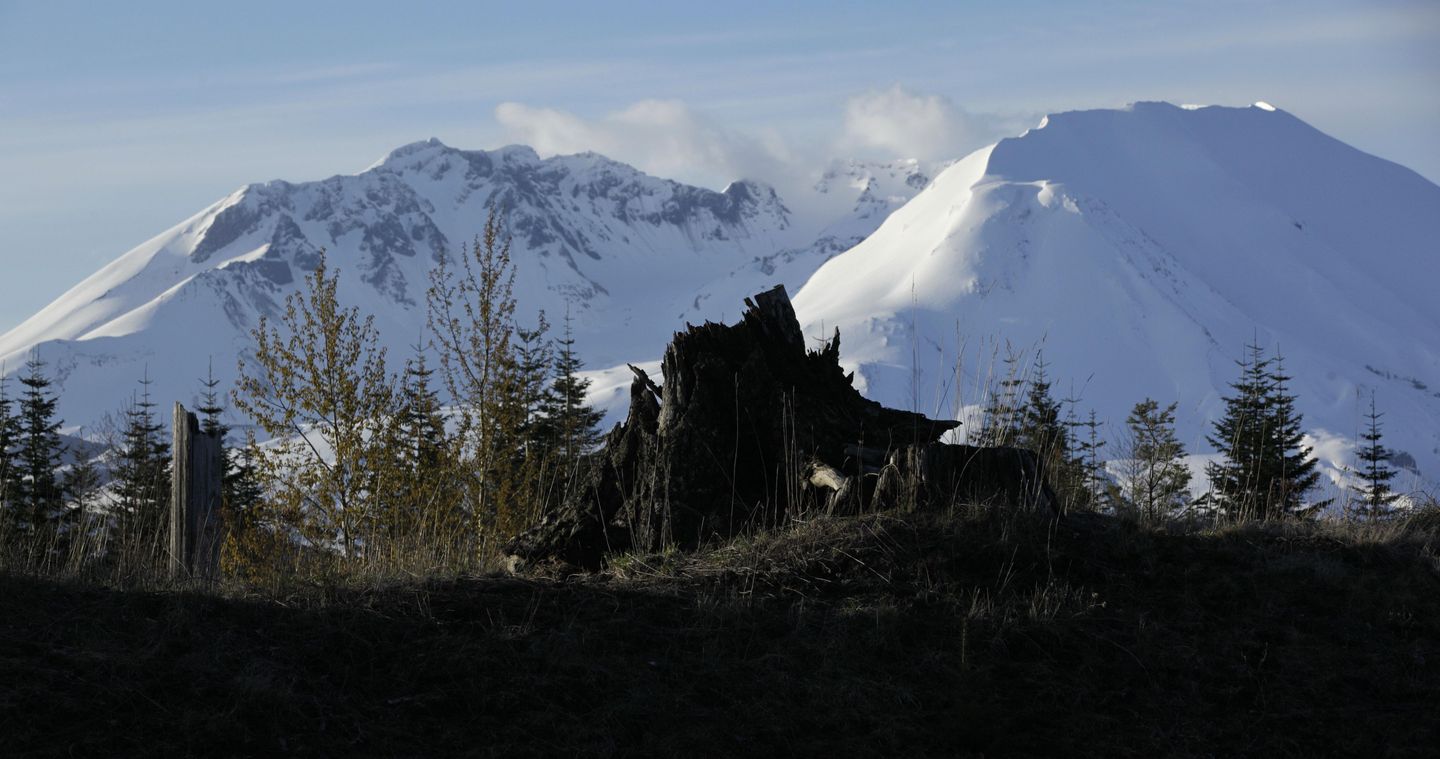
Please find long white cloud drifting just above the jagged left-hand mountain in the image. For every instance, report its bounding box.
[495,99,791,187]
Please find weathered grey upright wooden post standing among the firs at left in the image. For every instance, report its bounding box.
[170,403,225,580]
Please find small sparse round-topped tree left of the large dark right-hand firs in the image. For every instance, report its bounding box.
[1125,398,1189,520]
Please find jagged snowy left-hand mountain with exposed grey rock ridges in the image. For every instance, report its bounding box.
[0,140,923,428]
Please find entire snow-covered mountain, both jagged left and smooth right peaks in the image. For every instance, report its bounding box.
[0,104,1440,504]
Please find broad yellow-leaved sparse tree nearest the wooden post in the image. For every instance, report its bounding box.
[232,253,395,559]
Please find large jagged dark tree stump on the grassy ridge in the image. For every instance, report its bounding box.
[505,287,1054,567]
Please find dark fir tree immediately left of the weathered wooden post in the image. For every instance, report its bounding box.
[111,373,170,562]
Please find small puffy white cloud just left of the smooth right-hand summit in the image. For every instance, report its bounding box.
[837,85,1018,160]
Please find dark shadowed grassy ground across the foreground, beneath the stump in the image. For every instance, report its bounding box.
[0,507,1440,758]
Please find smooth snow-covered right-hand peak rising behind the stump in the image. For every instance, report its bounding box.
[795,102,1440,498]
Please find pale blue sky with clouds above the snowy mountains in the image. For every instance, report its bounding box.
[0,0,1440,331]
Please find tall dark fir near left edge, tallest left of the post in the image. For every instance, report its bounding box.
[13,353,65,531]
